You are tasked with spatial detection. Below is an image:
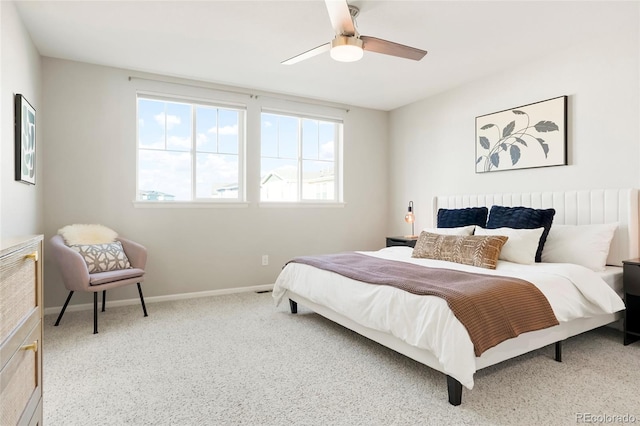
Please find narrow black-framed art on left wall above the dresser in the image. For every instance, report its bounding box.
[15,94,36,185]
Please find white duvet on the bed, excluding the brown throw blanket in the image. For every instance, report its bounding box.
[273,247,624,389]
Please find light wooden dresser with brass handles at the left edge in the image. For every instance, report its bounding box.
[0,235,43,426]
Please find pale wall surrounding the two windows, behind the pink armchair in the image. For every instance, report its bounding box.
[42,58,388,306]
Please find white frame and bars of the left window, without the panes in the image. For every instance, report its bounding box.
[134,91,247,207]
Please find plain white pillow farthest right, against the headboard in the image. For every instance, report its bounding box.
[542,223,618,272]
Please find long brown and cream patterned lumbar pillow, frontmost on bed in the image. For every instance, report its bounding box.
[412,231,508,269]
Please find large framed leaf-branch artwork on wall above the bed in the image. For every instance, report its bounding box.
[476,96,567,173]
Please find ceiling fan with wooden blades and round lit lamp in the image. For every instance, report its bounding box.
[282,0,427,65]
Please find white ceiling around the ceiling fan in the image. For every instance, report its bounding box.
[16,0,639,110]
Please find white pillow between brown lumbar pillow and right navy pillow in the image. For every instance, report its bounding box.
[476,226,546,265]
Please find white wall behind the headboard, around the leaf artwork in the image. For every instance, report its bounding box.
[388,15,640,234]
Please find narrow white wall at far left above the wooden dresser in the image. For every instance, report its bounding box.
[0,1,46,238]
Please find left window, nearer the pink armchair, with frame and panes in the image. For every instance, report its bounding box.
[136,94,245,201]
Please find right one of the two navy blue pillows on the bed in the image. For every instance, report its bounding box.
[487,206,556,262]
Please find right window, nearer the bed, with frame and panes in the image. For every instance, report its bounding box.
[260,112,342,202]
